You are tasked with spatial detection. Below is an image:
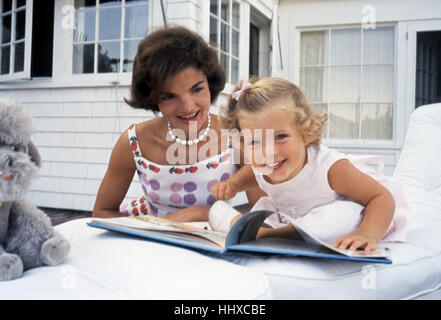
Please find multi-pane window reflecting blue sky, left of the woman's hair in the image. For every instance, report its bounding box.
[72,0,149,74]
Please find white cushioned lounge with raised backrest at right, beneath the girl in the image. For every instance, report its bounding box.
[222,104,441,299]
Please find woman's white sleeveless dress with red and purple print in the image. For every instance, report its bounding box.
[120,125,238,217]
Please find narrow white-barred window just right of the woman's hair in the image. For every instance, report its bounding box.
[210,0,240,85]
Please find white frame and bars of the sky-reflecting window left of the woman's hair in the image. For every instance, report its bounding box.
[66,0,154,85]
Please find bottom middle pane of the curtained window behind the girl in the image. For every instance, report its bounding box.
[328,104,359,139]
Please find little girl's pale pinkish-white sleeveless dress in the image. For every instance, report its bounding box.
[252,144,411,241]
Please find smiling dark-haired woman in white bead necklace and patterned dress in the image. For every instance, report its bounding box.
[93,27,260,222]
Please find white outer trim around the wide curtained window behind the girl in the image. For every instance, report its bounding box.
[292,23,398,150]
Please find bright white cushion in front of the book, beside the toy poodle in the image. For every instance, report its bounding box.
[0,219,273,300]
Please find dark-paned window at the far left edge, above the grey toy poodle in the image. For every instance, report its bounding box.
[0,0,30,79]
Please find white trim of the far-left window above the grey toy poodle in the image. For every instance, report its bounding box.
[0,0,33,83]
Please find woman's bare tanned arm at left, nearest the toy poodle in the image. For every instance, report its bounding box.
[92,131,136,218]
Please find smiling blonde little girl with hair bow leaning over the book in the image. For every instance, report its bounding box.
[209,78,410,251]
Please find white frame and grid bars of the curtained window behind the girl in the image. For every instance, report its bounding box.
[294,23,400,149]
